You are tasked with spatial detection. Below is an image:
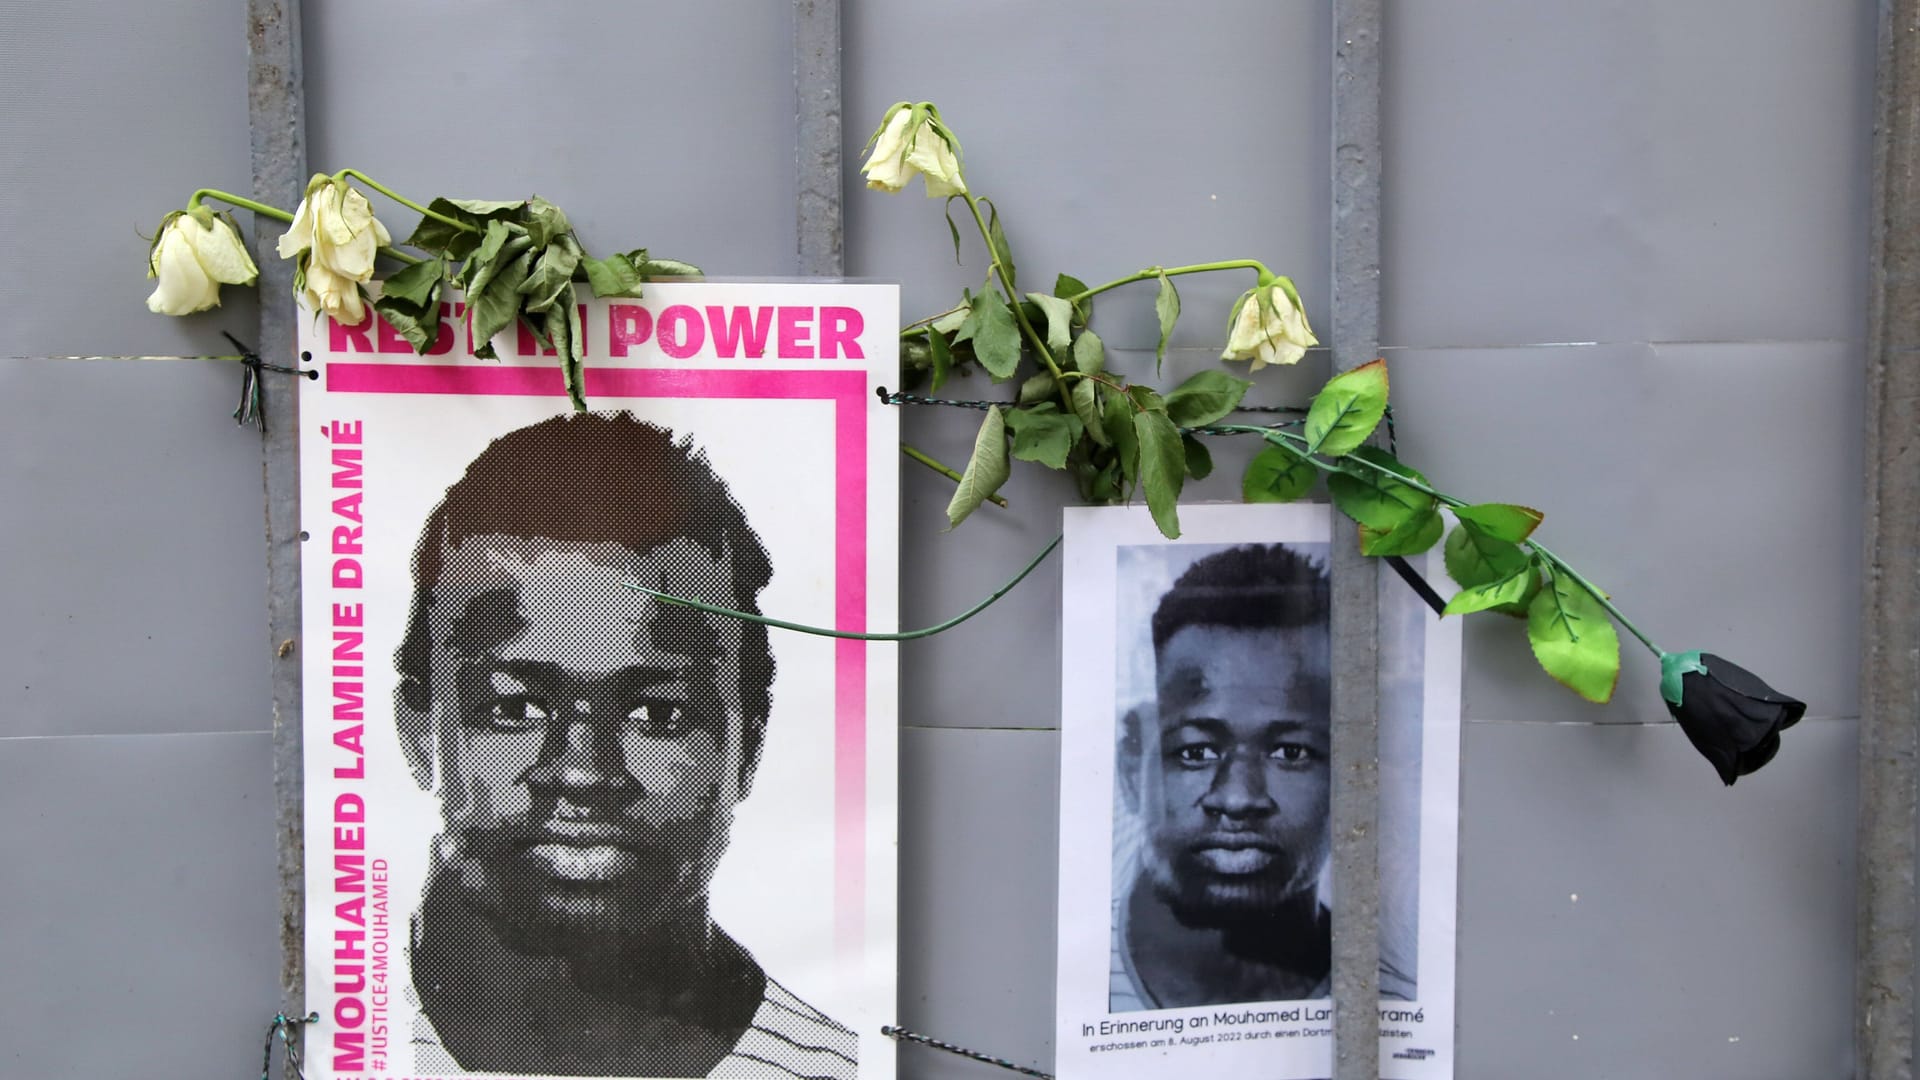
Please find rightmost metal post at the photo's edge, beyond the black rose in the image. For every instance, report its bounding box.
[1853,0,1920,1080]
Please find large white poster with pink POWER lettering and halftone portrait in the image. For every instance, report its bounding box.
[300,282,899,1080]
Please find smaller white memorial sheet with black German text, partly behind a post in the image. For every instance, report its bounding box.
[1056,503,1459,1080]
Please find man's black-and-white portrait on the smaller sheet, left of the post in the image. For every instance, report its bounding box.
[1108,544,1411,1013]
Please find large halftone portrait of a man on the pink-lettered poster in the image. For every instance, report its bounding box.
[396,413,856,1078]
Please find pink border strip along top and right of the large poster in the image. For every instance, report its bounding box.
[326,361,868,957]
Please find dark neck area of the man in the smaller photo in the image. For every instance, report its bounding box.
[1125,878,1331,1009]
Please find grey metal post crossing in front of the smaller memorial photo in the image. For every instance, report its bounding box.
[1331,0,1382,1080]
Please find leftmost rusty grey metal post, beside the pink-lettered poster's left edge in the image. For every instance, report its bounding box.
[246,0,307,1037]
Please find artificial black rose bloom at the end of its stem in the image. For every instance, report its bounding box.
[1661,653,1807,786]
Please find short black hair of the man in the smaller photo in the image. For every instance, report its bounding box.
[1154,544,1331,655]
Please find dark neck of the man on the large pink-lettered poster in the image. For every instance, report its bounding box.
[413,868,766,1076]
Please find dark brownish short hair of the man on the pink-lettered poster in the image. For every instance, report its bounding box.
[394,411,774,763]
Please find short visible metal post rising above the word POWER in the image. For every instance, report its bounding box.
[793,0,847,277]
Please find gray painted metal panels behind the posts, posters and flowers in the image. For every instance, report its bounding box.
[0,0,1874,1078]
